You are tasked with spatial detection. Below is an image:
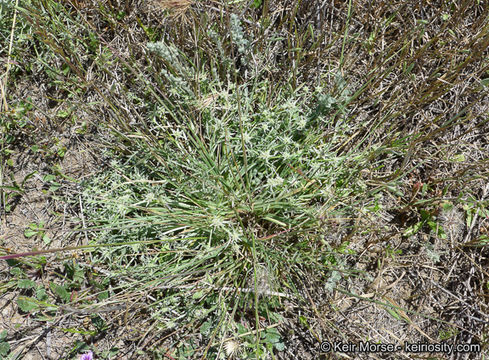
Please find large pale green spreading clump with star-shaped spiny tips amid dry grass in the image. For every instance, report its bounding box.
[84,35,367,356]
